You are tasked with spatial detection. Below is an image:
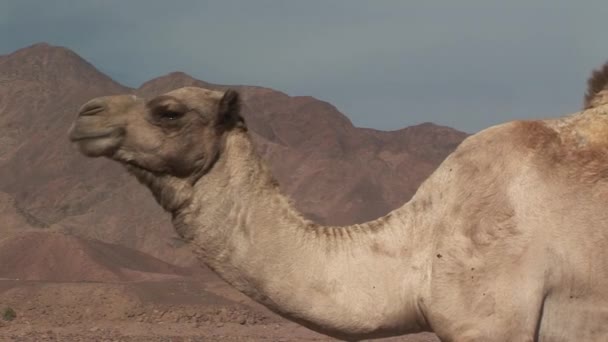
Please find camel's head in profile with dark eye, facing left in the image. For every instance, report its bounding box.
[69,87,245,178]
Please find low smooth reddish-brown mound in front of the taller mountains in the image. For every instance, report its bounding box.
[0,231,187,282]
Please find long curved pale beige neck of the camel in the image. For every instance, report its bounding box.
[176,133,425,337]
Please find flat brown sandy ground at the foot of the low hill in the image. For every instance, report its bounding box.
[0,280,438,342]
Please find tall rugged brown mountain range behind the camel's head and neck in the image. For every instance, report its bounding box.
[0,44,466,265]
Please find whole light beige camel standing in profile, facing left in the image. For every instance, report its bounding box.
[69,64,608,342]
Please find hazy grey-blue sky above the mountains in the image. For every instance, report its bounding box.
[0,0,608,132]
